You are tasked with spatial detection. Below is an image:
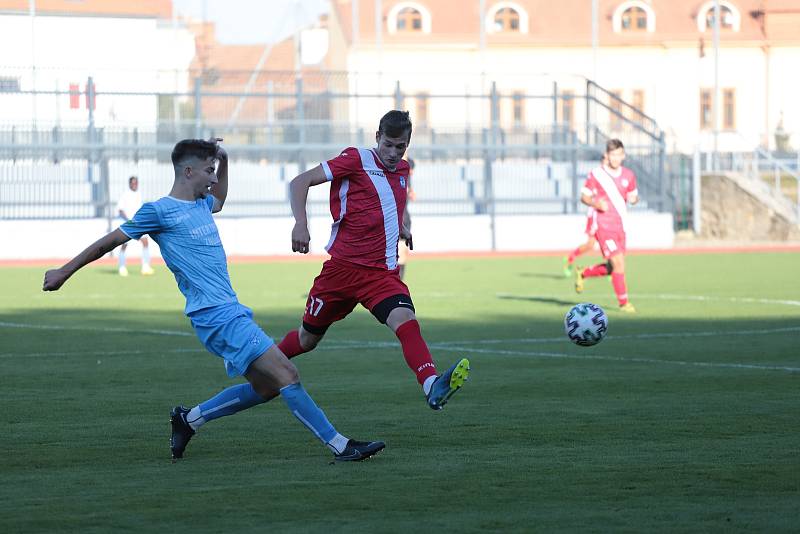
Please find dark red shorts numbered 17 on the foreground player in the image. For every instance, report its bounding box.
[303,259,413,330]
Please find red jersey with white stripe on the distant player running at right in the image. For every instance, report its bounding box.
[581,166,638,232]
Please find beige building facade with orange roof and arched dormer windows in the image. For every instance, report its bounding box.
[328,0,800,152]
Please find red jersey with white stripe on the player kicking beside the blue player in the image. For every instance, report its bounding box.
[322,147,409,270]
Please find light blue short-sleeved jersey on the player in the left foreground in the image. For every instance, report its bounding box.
[119,195,238,316]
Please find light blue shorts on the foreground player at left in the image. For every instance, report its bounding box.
[189,302,275,378]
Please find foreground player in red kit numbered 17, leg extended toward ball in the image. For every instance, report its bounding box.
[278,110,469,410]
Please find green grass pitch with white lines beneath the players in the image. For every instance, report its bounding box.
[0,252,800,533]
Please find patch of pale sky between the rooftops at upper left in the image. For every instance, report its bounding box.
[173,0,330,44]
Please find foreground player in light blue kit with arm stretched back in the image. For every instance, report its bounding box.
[43,138,385,461]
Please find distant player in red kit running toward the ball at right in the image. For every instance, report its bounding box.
[575,139,639,313]
